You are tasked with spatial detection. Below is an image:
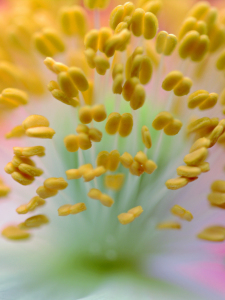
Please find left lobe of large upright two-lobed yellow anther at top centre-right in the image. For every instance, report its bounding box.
[131,8,145,37]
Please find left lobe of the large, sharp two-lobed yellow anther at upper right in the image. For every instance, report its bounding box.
[178,30,200,59]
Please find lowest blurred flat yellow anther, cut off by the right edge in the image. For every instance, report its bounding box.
[197,226,225,242]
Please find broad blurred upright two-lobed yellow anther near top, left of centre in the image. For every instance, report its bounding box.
[60,5,87,37]
